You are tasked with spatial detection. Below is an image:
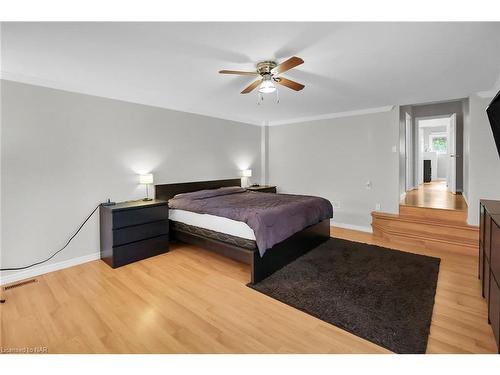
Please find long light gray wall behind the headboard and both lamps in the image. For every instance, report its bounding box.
[0,81,261,282]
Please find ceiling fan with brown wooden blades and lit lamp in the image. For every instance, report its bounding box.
[219,56,304,94]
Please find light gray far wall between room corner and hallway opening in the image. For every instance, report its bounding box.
[269,107,399,230]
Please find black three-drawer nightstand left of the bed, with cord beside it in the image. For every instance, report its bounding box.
[99,199,168,268]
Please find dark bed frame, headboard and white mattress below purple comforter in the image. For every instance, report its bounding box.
[155,178,331,284]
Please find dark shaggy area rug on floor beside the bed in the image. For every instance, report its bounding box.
[249,238,440,353]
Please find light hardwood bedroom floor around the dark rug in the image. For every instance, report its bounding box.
[0,228,496,353]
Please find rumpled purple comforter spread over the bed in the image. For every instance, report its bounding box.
[168,187,333,256]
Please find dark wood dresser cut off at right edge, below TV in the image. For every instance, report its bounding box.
[479,199,500,353]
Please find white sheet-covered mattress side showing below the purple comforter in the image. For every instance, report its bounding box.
[168,209,255,241]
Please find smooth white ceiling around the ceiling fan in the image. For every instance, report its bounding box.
[1,22,500,124]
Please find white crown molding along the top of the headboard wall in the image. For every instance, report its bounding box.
[0,70,262,126]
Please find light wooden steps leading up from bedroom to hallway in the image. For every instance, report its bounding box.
[372,209,479,254]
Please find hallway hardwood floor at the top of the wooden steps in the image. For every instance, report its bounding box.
[400,181,467,210]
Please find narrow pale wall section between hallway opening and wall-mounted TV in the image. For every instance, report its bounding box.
[464,95,500,225]
